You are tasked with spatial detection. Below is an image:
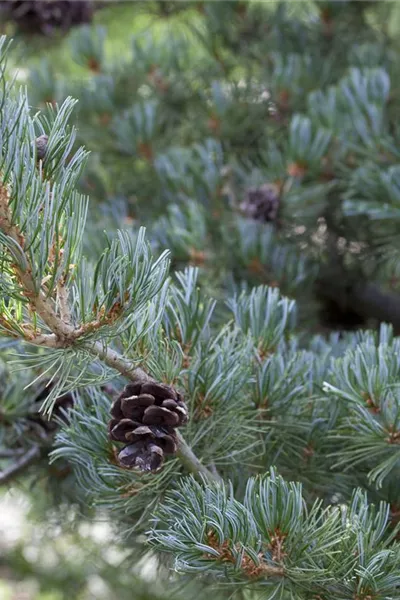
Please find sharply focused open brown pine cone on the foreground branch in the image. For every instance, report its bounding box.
[108,383,188,471]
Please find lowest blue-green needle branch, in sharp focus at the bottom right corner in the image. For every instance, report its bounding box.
[150,468,399,599]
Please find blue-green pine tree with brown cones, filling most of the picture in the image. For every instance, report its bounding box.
[0,0,400,600]
